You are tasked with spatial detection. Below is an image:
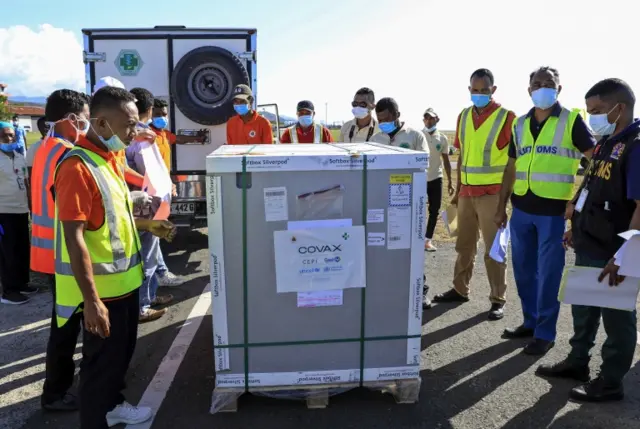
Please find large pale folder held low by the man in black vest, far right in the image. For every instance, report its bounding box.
[558,267,640,311]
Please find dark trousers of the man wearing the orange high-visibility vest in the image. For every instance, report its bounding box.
[42,275,82,403]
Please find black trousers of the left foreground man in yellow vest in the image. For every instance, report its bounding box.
[78,289,140,429]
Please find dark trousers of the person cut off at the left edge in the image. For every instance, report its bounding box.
[0,213,31,294]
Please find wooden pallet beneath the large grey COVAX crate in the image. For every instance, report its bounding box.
[216,379,420,413]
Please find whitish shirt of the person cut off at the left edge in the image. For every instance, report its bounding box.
[0,152,29,214]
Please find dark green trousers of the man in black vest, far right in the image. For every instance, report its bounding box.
[569,252,638,383]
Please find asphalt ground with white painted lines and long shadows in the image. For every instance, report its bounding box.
[0,230,640,429]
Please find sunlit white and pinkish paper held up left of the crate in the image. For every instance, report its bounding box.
[140,142,172,220]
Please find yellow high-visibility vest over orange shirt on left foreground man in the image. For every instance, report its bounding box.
[54,146,144,327]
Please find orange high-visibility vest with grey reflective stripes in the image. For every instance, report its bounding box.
[31,137,73,274]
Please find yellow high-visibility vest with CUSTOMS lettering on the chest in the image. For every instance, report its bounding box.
[513,108,582,200]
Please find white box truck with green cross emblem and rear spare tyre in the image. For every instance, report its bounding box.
[82,26,264,228]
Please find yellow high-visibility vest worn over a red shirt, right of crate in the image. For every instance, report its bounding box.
[458,107,509,185]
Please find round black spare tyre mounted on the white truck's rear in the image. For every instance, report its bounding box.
[171,46,250,125]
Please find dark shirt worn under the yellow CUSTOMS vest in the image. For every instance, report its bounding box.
[509,103,596,216]
